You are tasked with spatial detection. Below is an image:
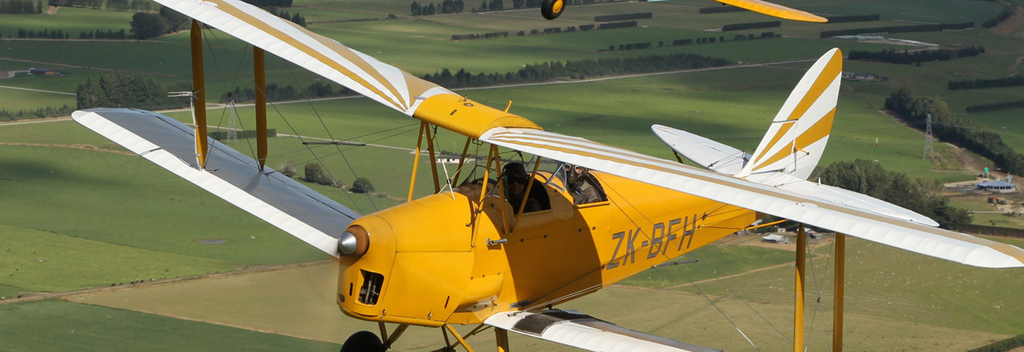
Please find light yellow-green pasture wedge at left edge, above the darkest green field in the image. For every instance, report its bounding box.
[0,224,242,296]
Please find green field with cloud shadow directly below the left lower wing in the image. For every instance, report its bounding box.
[0,143,326,265]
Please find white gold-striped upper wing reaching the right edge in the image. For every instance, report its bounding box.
[480,128,1024,268]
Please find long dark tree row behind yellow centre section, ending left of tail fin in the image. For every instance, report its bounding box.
[423,53,731,88]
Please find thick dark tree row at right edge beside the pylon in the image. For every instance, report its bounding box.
[886,89,1024,175]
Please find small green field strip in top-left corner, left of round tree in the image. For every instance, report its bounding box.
[0,6,134,36]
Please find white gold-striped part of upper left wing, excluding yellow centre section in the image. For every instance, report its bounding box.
[157,0,455,116]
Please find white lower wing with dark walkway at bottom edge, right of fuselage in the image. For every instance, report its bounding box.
[483,310,721,352]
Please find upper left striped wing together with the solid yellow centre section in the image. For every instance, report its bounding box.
[156,0,540,138]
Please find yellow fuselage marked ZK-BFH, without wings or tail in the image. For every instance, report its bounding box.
[338,168,755,326]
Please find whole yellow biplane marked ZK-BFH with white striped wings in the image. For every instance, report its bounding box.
[74,0,1024,351]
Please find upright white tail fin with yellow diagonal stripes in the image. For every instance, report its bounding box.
[736,48,843,179]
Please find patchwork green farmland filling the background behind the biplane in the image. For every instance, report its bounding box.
[0,0,1024,351]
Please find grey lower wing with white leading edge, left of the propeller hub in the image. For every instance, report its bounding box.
[72,108,359,257]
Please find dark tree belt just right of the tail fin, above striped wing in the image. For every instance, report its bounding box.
[817,159,972,230]
